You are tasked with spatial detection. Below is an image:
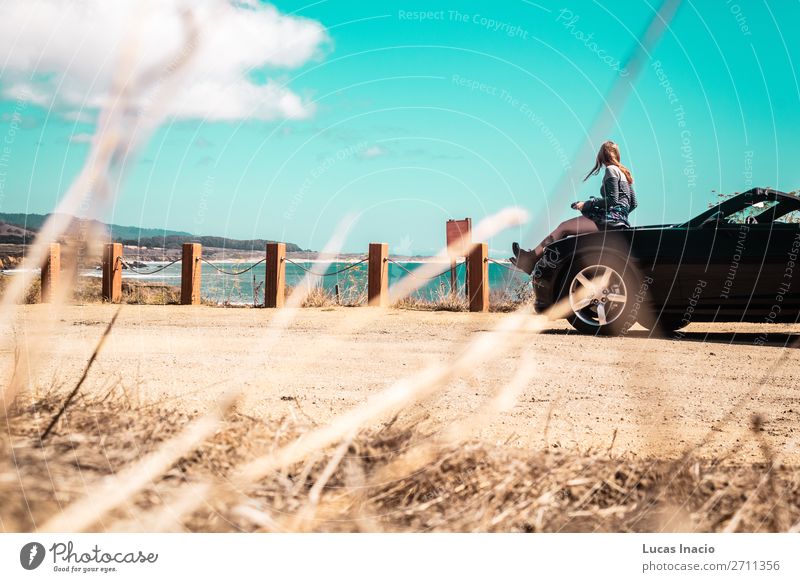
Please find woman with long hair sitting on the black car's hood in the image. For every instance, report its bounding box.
[510,141,637,275]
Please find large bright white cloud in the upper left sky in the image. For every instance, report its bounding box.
[0,0,328,120]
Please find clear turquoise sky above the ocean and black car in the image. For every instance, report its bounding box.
[0,0,800,256]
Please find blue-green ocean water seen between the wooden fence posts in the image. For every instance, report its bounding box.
[84,259,530,304]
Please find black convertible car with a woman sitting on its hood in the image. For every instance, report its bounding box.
[533,188,800,334]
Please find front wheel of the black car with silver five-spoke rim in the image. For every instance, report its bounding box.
[562,256,639,335]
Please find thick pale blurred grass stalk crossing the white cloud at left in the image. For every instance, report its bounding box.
[0,3,199,415]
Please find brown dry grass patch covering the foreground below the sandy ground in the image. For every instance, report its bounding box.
[0,396,800,532]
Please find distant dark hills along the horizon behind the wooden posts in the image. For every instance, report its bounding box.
[0,212,303,252]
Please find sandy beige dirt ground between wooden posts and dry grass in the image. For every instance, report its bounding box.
[6,305,800,465]
